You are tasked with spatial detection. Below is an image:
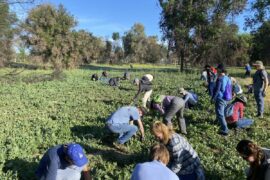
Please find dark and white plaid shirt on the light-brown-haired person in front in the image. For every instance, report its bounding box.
[166,133,200,175]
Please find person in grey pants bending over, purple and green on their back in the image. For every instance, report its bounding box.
[151,95,187,134]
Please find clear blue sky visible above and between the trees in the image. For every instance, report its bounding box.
[13,0,253,38]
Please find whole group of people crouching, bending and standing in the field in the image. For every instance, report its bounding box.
[36,61,270,180]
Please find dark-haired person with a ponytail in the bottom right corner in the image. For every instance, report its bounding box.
[236,140,270,180]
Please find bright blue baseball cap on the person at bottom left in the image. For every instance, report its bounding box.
[67,143,88,167]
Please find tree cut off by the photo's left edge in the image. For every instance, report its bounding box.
[0,0,17,67]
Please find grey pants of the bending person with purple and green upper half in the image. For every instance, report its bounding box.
[164,97,187,134]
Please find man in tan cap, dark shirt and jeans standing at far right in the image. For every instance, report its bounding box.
[253,61,269,118]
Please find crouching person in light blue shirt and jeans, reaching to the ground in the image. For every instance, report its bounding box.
[106,106,144,149]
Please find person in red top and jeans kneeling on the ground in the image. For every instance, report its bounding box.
[225,96,253,128]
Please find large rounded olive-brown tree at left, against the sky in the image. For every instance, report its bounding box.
[23,4,76,69]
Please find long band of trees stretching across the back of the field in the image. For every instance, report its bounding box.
[0,0,270,70]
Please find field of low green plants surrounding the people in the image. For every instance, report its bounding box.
[0,66,270,180]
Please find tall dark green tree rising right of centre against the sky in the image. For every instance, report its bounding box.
[159,0,249,71]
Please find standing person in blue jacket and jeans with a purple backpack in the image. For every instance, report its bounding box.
[211,69,232,136]
